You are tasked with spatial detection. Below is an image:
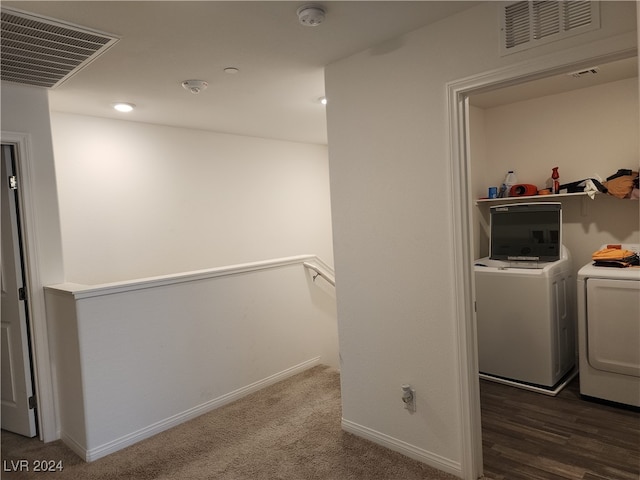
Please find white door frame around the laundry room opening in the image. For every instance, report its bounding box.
[446,38,640,480]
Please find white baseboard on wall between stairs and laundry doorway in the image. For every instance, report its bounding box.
[342,418,462,478]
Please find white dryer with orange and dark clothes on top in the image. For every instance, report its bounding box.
[577,244,640,407]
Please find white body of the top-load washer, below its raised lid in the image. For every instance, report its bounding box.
[474,246,576,395]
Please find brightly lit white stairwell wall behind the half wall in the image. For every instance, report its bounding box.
[52,113,333,284]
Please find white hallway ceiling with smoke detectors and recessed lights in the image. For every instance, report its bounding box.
[2,0,477,144]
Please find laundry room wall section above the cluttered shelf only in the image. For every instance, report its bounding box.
[480,77,640,197]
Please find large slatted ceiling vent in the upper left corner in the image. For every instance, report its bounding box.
[0,8,118,88]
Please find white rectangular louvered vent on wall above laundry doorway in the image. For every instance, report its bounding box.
[500,0,600,55]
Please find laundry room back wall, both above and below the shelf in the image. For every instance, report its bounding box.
[470,77,640,271]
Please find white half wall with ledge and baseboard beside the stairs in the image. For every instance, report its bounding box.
[47,257,338,461]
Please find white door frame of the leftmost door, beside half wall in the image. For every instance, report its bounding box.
[0,131,60,442]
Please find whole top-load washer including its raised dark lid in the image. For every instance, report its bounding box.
[474,202,576,395]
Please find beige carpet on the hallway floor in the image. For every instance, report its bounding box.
[2,366,456,480]
